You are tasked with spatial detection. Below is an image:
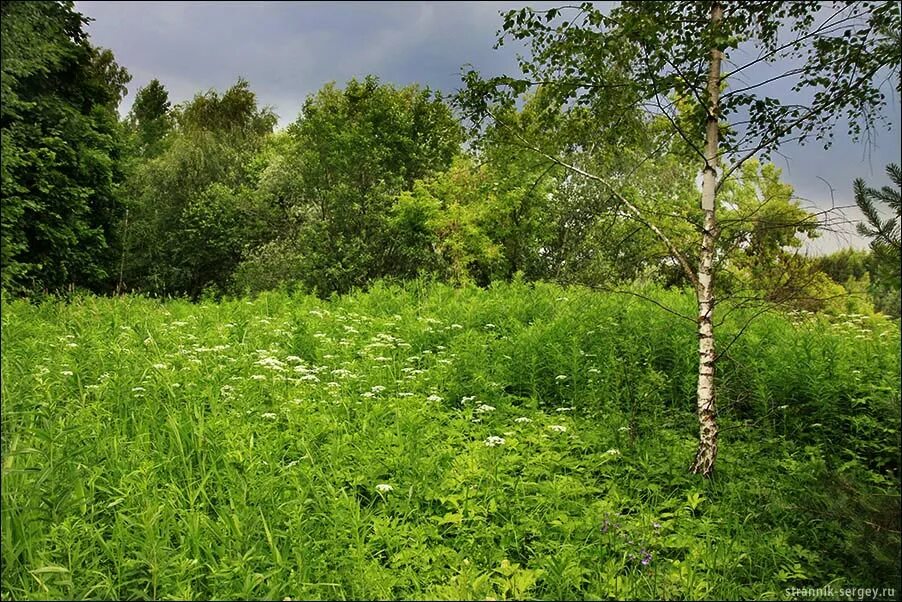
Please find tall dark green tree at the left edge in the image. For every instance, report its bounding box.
[0,2,130,291]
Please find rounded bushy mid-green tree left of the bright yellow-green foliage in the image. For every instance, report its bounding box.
[245,77,462,295]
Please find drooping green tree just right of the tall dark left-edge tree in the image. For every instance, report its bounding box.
[122,80,276,297]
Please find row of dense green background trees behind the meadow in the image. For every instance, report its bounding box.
[2,2,898,314]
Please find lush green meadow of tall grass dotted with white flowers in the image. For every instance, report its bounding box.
[0,284,900,600]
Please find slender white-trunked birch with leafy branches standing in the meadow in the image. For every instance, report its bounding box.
[459,1,902,476]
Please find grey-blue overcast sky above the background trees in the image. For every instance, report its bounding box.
[76,2,902,251]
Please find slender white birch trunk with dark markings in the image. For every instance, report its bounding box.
[691,4,723,476]
